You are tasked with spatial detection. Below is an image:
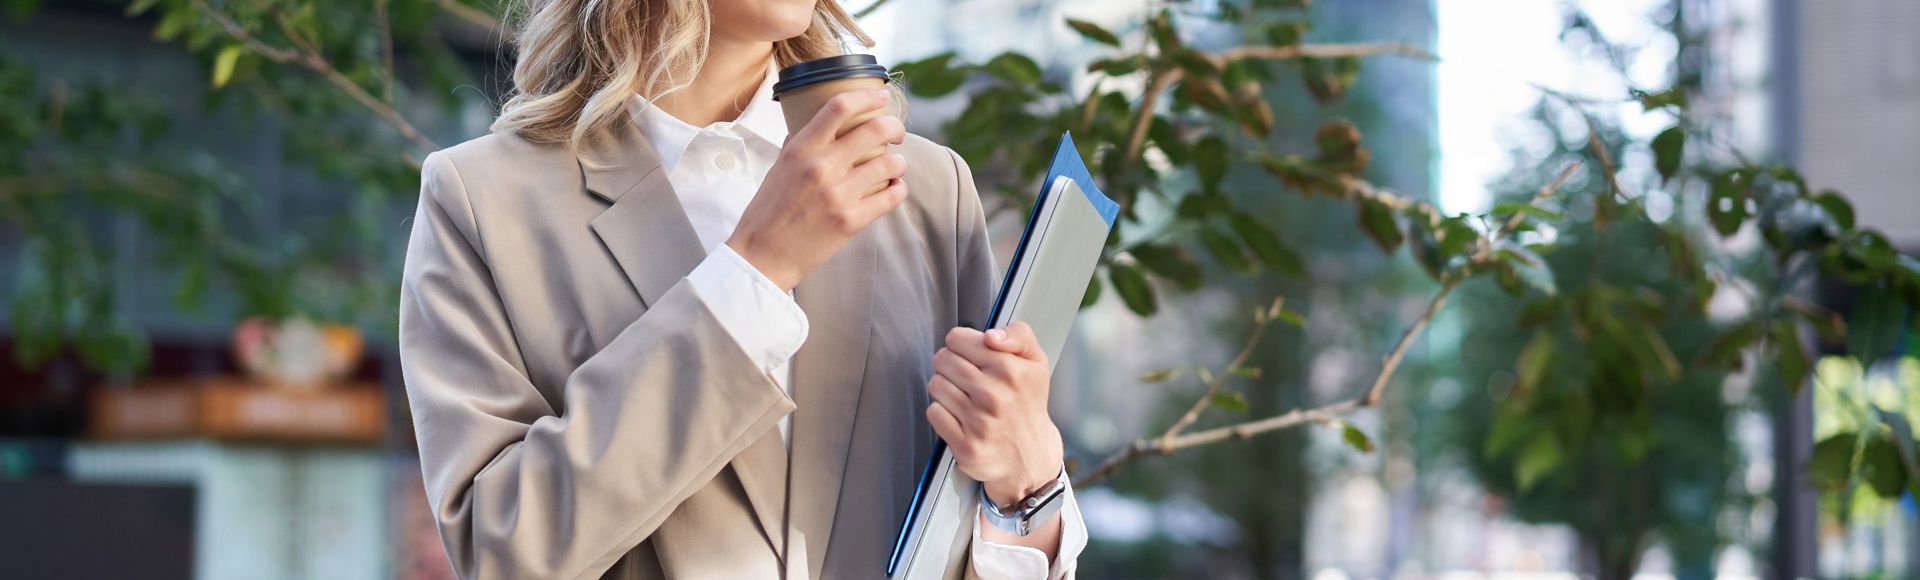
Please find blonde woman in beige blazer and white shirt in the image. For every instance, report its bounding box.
[399,0,1085,578]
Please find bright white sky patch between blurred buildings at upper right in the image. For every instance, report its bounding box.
[1438,0,1674,213]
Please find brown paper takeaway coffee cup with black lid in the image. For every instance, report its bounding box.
[774,54,906,178]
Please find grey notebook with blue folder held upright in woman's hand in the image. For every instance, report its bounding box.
[887,134,1119,580]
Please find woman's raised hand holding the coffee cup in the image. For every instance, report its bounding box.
[726,90,906,290]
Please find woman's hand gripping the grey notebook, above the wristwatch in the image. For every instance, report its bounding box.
[927,323,1064,505]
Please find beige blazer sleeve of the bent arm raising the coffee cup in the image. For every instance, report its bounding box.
[399,154,793,578]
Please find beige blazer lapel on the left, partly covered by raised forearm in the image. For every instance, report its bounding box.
[580,114,787,555]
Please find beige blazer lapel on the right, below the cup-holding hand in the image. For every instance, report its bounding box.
[787,232,874,578]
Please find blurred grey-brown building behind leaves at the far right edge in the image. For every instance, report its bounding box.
[1755,0,1920,578]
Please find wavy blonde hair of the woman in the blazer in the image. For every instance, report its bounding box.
[493,0,874,150]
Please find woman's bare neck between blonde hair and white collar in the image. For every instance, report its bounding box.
[655,38,774,127]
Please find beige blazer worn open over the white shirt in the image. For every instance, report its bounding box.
[399,123,995,578]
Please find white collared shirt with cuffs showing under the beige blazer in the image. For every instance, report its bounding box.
[630,61,1087,578]
